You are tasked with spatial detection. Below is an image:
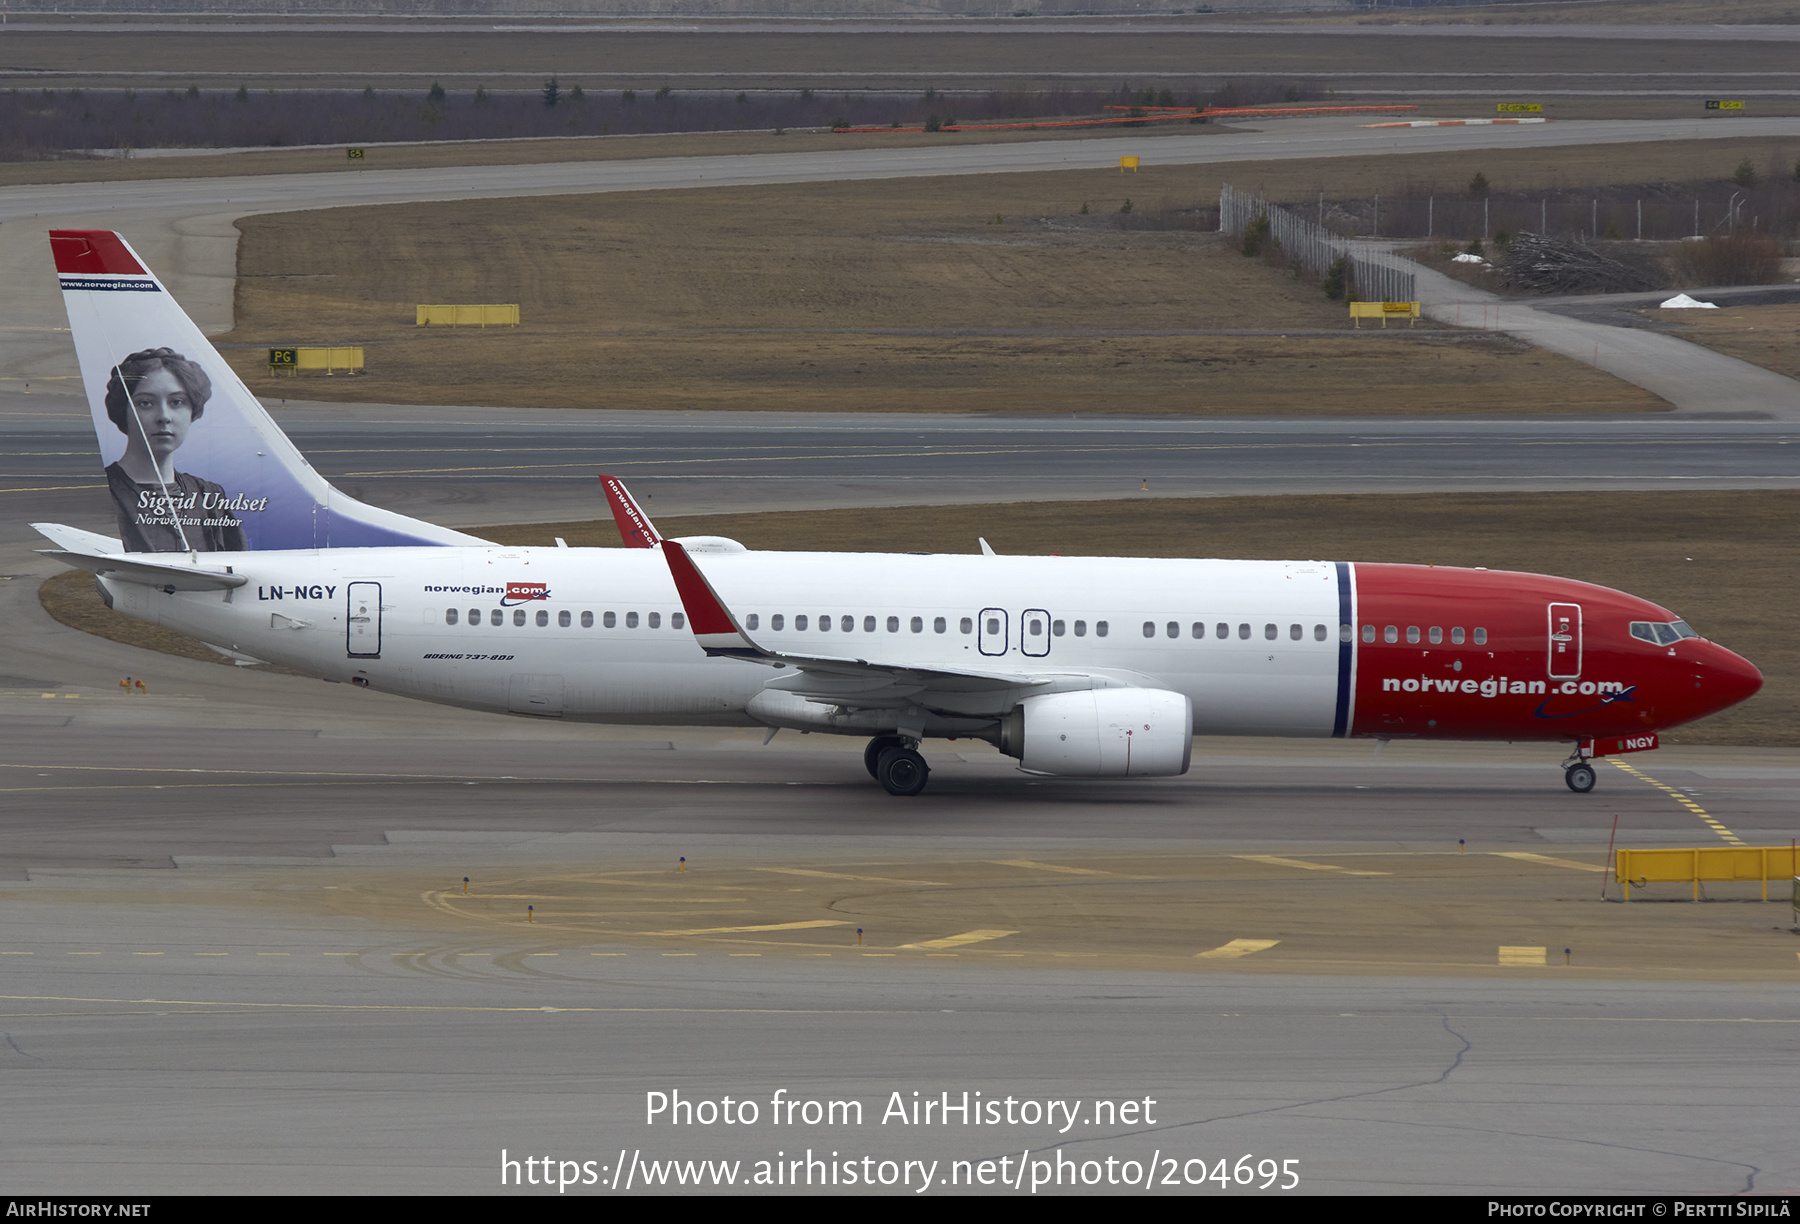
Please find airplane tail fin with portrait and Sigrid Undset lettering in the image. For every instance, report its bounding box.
[50,230,486,553]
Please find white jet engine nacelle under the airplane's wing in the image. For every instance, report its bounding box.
[1001,689,1193,778]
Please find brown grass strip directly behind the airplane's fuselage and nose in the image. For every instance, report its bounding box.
[40,491,1800,747]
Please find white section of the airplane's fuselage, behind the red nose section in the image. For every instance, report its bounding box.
[108,547,1341,736]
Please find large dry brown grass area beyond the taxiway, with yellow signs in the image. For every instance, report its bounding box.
[225,167,1661,416]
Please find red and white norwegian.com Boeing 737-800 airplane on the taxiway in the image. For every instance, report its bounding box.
[38,230,1762,794]
